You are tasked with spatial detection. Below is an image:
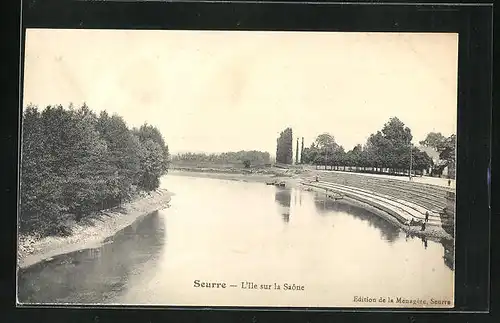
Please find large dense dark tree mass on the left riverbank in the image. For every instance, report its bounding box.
[20,104,169,235]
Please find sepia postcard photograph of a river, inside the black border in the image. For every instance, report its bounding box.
[17,28,460,309]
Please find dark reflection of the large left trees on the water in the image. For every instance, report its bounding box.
[18,212,165,303]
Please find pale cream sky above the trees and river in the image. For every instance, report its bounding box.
[23,29,458,155]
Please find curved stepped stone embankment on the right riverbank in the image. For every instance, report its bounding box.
[300,172,454,239]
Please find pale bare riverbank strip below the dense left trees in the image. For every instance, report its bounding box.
[17,189,173,268]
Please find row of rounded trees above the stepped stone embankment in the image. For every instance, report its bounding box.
[302,117,455,174]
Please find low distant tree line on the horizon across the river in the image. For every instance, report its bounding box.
[172,150,271,168]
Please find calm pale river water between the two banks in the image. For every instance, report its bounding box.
[18,175,454,307]
